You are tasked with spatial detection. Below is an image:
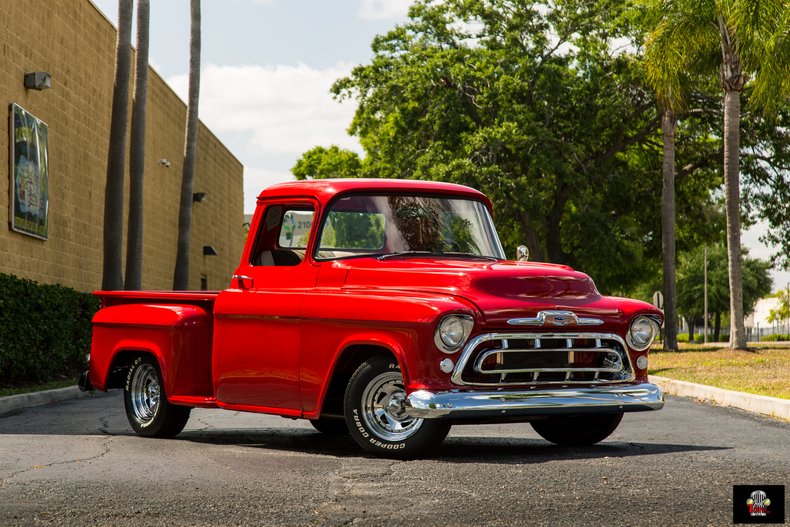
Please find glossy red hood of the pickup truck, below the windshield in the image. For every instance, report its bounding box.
[338,258,636,328]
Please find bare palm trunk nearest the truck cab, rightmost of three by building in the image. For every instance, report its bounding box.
[173,0,200,290]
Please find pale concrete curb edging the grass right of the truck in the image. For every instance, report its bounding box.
[650,375,790,421]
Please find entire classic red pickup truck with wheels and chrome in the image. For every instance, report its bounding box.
[80,179,664,458]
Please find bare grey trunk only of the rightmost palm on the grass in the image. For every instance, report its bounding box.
[724,90,746,349]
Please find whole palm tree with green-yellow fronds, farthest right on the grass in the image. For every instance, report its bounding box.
[651,0,790,349]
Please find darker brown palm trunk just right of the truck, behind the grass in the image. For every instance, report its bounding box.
[661,108,680,351]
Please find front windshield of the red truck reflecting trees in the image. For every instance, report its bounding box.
[316,194,504,260]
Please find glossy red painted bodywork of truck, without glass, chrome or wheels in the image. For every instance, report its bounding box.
[89,180,663,418]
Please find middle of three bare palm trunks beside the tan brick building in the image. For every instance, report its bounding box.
[124,0,150,290]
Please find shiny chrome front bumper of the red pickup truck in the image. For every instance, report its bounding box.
[406,383,664,420]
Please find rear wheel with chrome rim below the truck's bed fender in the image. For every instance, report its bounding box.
[123,356,192,437]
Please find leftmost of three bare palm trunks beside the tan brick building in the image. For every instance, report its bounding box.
[102,0,132,291]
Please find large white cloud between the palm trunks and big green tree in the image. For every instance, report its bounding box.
[168,63,360,160]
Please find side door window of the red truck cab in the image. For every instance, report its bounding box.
[250,204,315,267]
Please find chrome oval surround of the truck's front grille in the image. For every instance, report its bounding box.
[450,333,635,387]
